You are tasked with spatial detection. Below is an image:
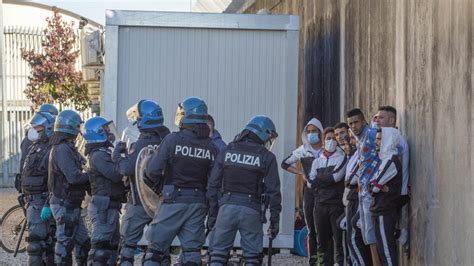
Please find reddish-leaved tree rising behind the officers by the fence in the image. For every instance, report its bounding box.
[21,10,90,111]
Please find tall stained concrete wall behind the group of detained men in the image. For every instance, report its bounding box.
[243,0,474,265]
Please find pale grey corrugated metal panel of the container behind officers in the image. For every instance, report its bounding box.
[117,27,290,159]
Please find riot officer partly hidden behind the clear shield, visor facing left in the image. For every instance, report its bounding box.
[112,100,170,265]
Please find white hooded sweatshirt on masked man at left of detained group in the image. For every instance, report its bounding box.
[281,118,323,176]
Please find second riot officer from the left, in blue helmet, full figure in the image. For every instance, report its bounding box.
[48,110,90,265]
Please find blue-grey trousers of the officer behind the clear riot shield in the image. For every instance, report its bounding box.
[120,200,152,265]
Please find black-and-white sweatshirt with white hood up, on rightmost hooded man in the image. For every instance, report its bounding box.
[370,127,402,216]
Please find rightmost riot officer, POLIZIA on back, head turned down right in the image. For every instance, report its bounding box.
[207,116,281,265]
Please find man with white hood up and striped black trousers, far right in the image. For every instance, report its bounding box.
[369,127,403,265]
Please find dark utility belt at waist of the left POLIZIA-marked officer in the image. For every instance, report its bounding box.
[162,185,206,203]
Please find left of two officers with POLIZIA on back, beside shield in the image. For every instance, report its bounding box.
[143,97,218,266]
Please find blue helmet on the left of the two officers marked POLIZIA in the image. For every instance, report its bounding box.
[174,97,209,127]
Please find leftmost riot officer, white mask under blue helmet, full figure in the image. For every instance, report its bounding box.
[21,112,54,265]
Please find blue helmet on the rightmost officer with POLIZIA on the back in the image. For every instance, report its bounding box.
[245,115,278,150]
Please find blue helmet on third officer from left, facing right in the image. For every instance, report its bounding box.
[82,116,117,144]
